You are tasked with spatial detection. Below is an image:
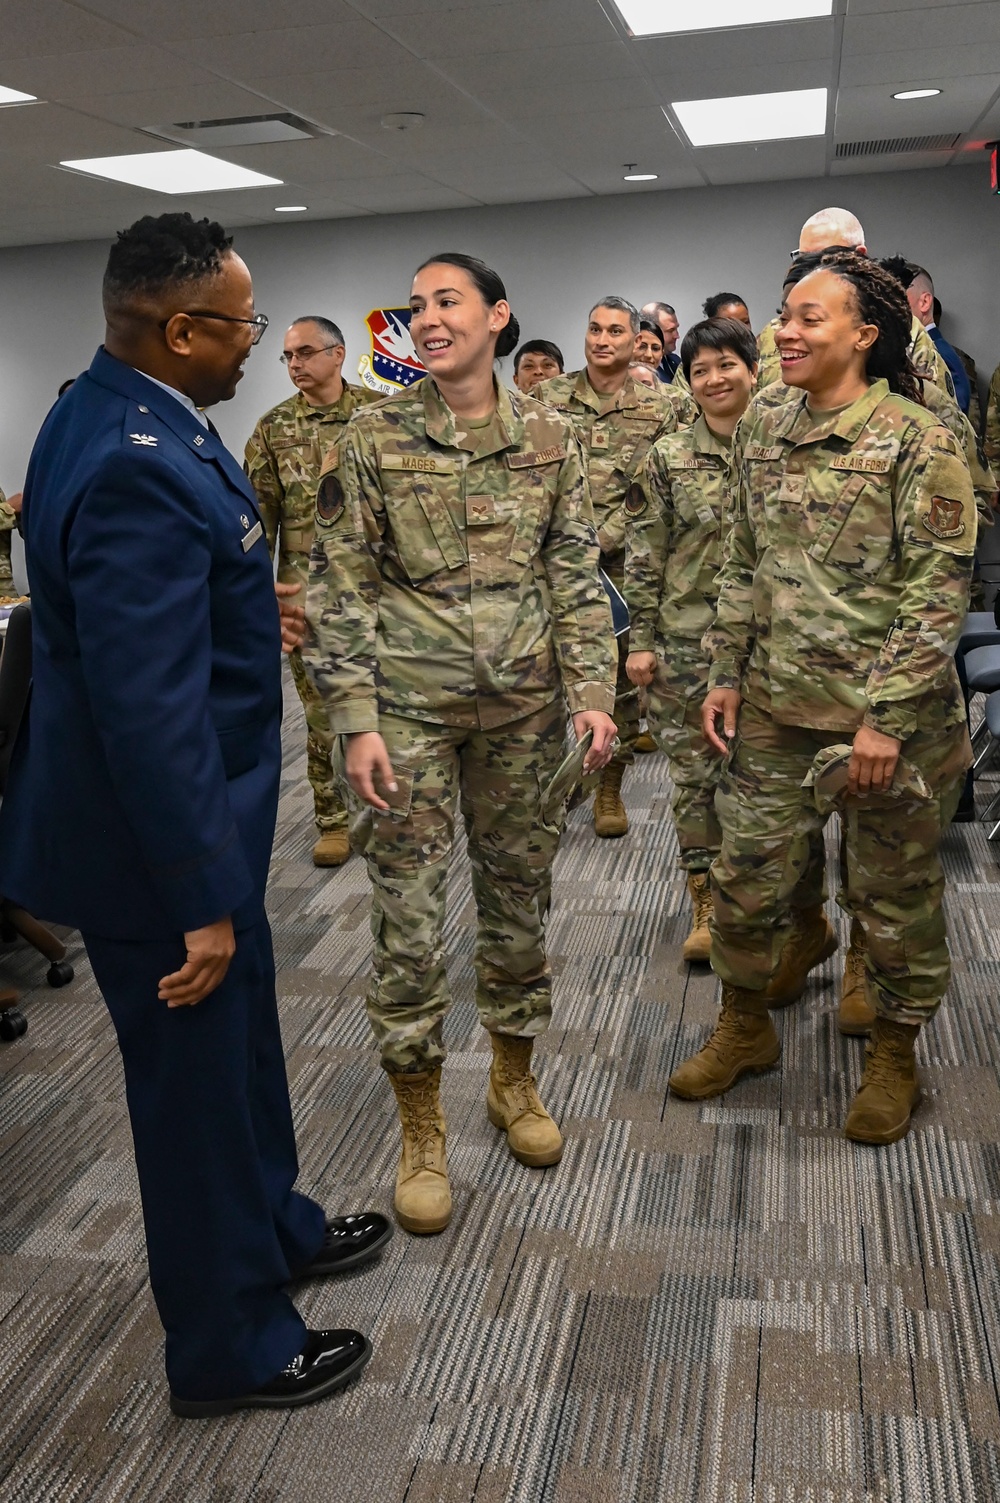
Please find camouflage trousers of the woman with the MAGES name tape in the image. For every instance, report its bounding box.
[342,699,565,1073]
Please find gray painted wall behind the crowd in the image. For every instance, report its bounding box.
[0,162,1000,491]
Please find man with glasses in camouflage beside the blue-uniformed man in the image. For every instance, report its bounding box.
[247,316,379,866]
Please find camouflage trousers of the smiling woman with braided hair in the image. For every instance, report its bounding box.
[711,703,970,1024]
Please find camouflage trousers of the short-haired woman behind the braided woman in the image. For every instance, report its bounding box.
[648,643,723,872]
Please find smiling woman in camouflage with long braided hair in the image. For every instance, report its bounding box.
[661,253,976,1144]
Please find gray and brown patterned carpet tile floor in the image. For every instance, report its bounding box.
[0,676,1000,1503]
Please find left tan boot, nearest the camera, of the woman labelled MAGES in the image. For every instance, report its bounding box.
[386,1066,451,1235]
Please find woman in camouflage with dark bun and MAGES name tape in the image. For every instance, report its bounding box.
[304,251,617,1232]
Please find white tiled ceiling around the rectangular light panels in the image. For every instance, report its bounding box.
[0,0,1000,245]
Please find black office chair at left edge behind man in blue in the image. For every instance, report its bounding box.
[0,606,74,1043]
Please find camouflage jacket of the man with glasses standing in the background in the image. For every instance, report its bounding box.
[244,382,379,598]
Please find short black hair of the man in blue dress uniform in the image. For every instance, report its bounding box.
[102,213,233,313]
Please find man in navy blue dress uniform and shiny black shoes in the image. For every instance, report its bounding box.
[0,213,391,1417]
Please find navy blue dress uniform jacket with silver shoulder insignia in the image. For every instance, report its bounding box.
[0,349,281,941]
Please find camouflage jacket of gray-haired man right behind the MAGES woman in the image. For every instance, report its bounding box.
[534,370,698,577]
